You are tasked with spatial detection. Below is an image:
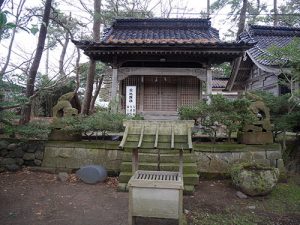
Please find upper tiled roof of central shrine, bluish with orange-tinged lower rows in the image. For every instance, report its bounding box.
[102,19,220,44]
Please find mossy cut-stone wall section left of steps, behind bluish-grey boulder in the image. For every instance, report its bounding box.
[42,141,123,173]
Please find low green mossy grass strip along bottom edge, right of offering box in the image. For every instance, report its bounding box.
[190,212,269,225]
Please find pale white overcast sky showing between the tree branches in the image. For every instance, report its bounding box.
[0,0,285,80]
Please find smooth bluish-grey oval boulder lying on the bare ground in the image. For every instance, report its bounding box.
[76,165,107,184]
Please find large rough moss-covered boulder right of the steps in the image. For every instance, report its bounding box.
[231,163,279,196]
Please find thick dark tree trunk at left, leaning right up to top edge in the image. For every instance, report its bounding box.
[20,0,52,124]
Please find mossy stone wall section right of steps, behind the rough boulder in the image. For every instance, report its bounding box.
[194,144,284,176]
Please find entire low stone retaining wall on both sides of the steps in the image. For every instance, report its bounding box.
[0,140,284,176]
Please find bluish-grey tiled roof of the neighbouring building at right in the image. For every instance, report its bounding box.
[240,25,300,66]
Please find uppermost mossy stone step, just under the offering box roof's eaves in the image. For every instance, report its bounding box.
[122,152,196,163]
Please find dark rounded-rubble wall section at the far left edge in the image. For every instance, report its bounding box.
[0,139,45,172]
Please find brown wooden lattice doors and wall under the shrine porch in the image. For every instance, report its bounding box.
[121,76,200,112]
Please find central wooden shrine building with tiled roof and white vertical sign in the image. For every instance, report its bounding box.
[73,18,253,119]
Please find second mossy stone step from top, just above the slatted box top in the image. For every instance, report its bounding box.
[121,162,197,174]
